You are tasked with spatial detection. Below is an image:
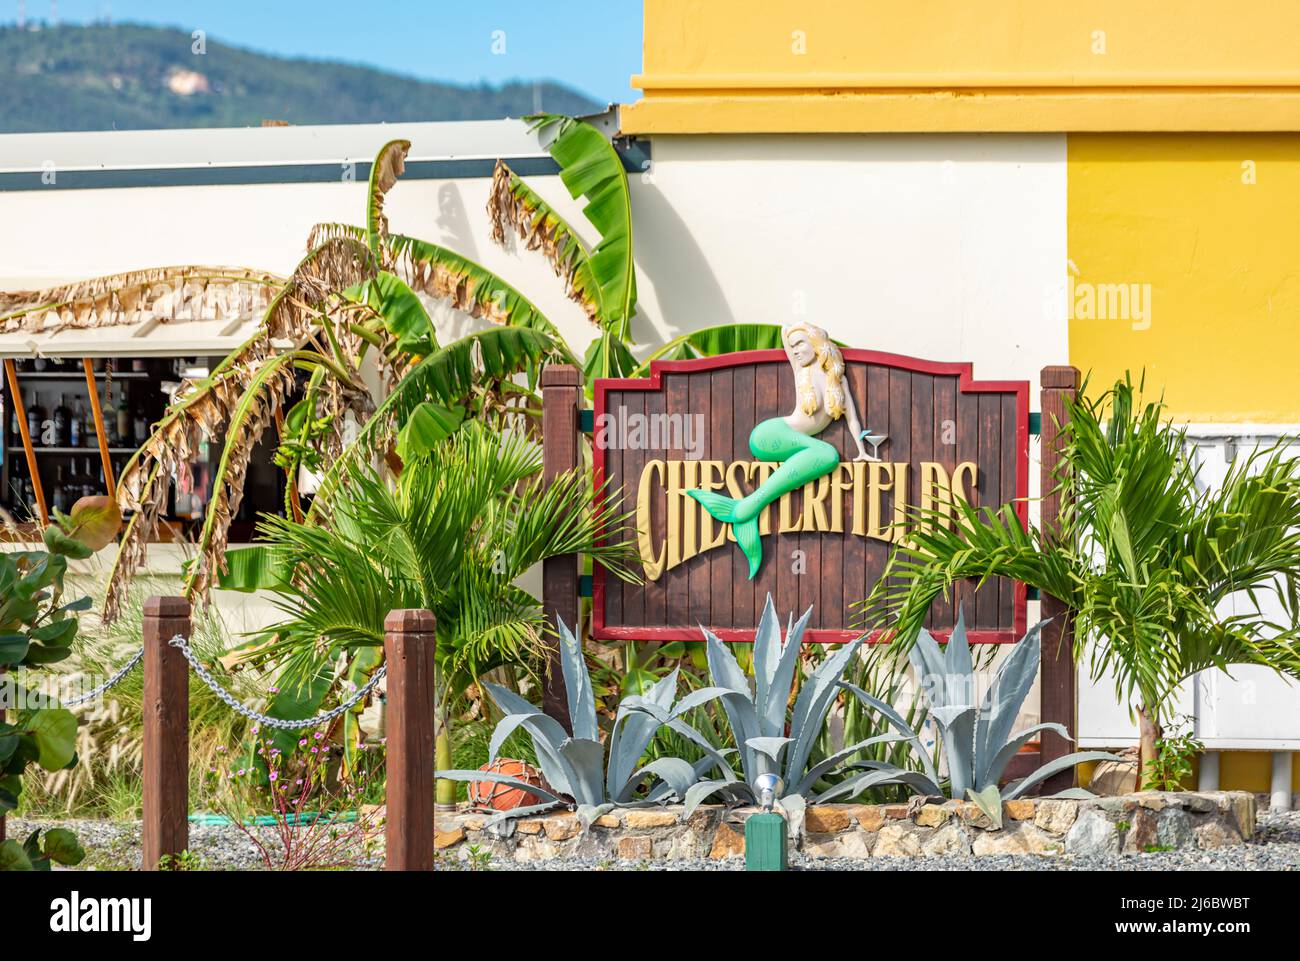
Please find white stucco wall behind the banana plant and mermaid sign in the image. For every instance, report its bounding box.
[0,125,1067,381]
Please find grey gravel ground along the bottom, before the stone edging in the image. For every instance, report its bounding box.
[8,811,1300,871]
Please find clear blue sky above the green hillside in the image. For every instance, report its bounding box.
[15,0,641,103]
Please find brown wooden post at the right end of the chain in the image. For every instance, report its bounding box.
[384,610,434,871]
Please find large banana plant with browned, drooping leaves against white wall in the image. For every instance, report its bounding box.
[0,114,780,623]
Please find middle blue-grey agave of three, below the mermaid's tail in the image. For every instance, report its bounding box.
[633,594,898,817]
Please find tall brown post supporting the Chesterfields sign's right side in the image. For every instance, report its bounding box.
[1039,367,1079,795]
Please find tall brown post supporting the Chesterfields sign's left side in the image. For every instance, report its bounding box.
[542,364,582,733]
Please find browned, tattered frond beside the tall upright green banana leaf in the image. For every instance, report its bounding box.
[488,160,603,325]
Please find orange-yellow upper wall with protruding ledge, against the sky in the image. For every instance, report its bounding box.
[621,0,1300,134]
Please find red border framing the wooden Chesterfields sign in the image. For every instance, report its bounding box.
[592,347,1030,644]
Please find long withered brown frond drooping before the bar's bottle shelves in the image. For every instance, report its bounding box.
[104,238,374,623]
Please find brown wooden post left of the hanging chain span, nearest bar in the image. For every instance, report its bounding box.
[143,597,190,871]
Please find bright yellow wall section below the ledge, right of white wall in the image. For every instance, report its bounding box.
[1067,134,1300,424]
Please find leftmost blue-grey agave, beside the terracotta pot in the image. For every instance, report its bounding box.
[437,620,728,824]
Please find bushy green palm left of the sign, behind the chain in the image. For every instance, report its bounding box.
[229,424,633,806]
